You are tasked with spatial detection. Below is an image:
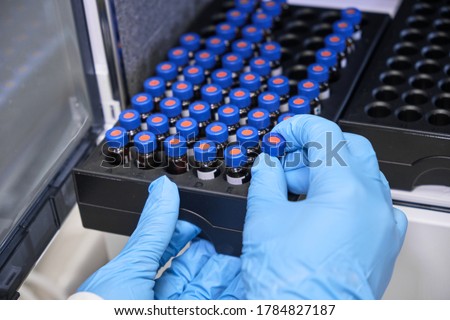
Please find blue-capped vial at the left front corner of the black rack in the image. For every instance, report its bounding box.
[104,127,129,166]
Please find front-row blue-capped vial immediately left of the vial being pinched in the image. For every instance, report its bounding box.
[225,145,250,185]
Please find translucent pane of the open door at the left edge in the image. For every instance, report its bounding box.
[0,0,92,245]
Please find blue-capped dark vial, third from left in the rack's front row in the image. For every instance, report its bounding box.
[164,135,188,174]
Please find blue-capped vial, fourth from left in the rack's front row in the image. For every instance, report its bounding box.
[194,140,220,180]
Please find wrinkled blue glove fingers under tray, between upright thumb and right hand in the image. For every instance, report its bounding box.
[155,238,245,300]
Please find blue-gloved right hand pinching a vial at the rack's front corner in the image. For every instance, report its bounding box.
[241,115,407,299]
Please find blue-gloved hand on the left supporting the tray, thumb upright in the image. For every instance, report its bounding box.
[78,177,240,299]
